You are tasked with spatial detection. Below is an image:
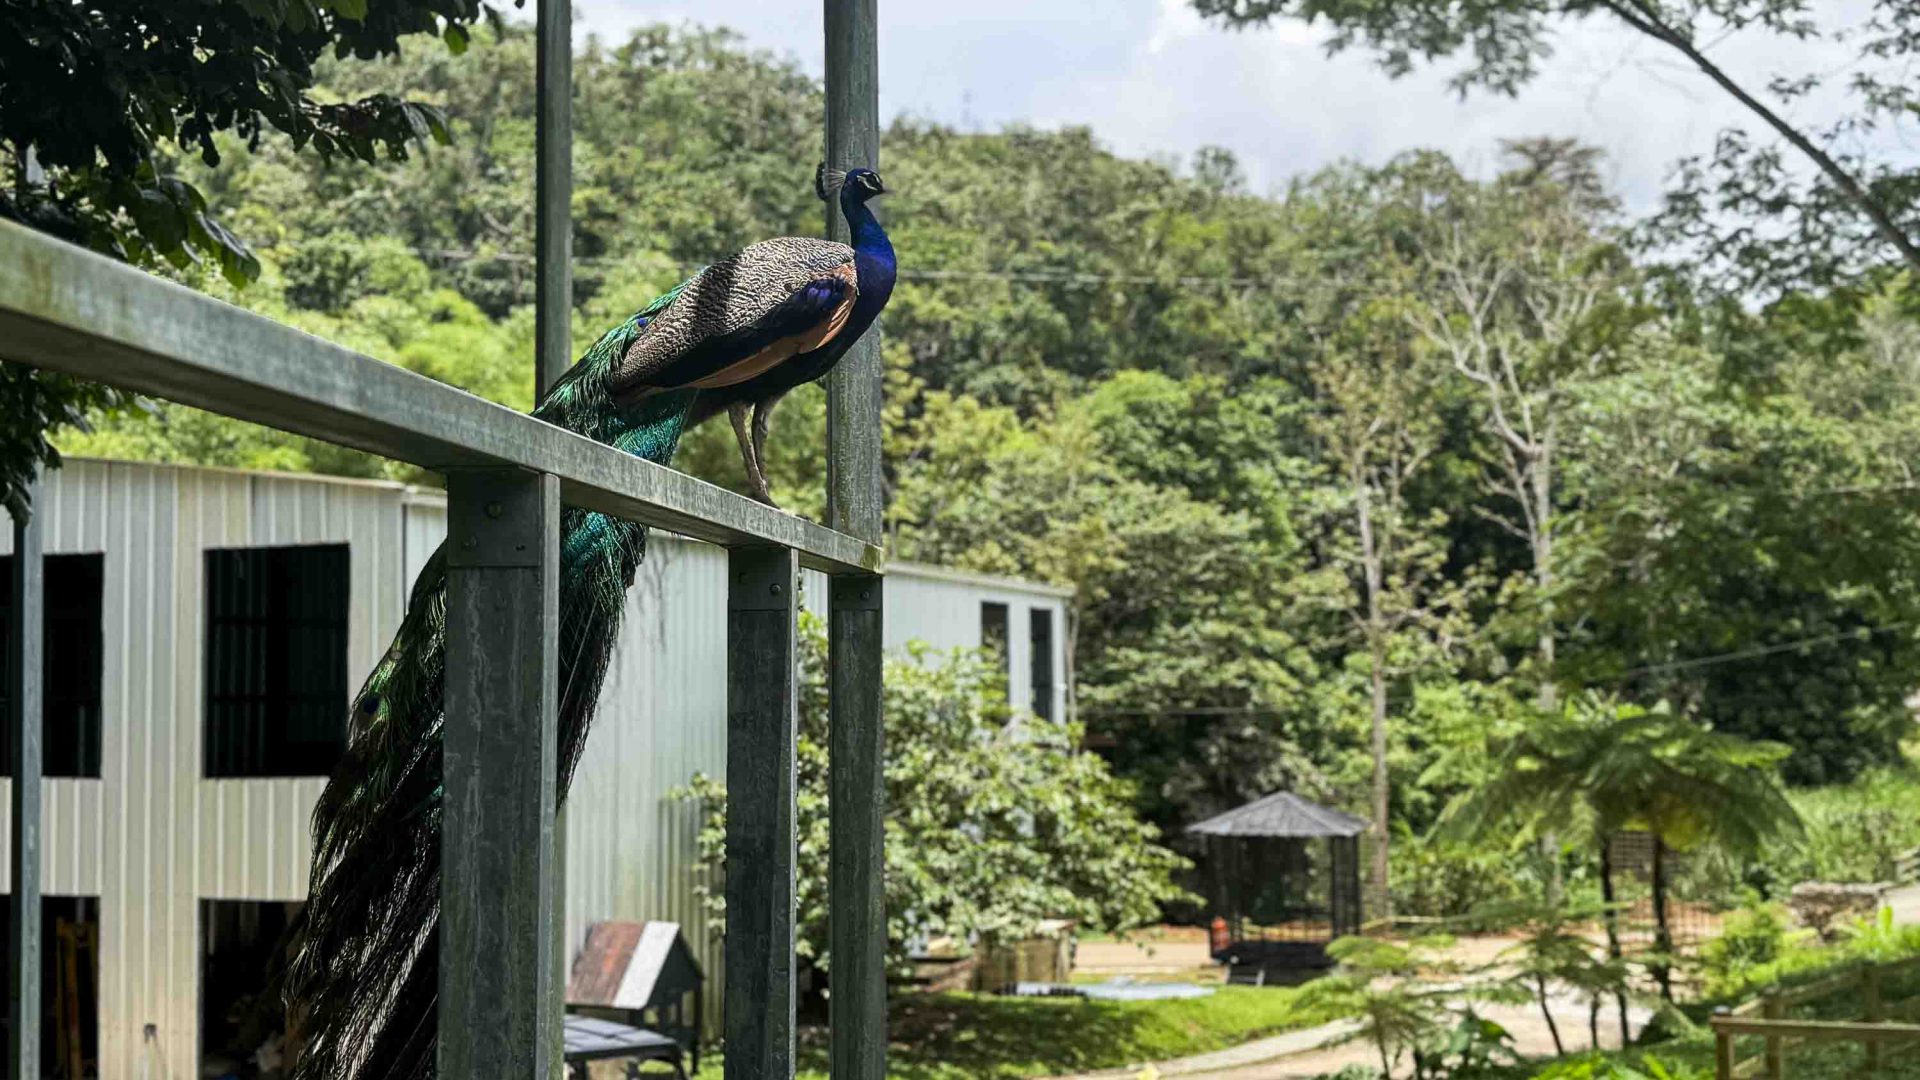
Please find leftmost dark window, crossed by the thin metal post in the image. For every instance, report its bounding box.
[0,553,106,776]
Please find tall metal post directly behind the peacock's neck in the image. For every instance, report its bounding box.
[826,0,887,1080]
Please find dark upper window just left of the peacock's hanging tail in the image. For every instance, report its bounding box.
[205,544,348,776]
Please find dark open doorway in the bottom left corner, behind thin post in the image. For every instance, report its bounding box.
[0,896,100,1080]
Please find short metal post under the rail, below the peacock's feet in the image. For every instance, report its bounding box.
[726,548,801,1080]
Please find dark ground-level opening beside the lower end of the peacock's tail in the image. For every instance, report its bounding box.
[200,899,300,1080]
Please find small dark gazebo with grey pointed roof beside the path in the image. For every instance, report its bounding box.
[1187,792,1367,984]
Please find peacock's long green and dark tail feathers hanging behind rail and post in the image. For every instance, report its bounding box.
[280,305,695,1080]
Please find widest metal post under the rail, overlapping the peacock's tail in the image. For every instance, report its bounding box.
[440,471,561,1078]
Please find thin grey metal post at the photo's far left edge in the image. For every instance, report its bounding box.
[6,480,44,1080]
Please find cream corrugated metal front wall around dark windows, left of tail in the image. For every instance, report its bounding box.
[0,461,405,1076]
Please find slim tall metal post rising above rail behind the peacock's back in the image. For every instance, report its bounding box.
[534,0,574,1080]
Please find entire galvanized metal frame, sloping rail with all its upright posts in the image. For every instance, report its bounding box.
[0,0,885,1080]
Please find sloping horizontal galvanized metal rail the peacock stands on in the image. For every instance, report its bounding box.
[0,221,881,573]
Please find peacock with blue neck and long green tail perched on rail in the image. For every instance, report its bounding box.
[282,165,895,1080]
